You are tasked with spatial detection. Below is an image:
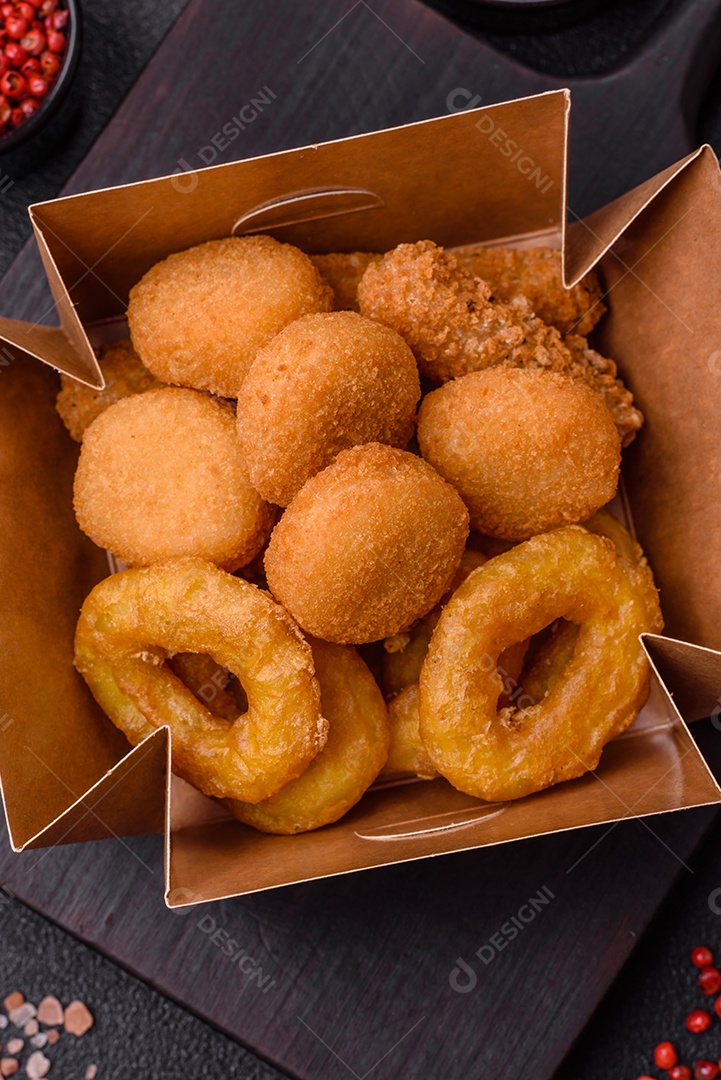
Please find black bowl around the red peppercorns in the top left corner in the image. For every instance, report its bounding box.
[0,0,82,176]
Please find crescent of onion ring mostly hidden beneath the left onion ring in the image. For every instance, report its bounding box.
[228,639,390,834]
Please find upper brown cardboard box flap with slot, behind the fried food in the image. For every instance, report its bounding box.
[16,91,569,362]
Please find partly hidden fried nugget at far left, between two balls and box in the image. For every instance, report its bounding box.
[55,338,165,443]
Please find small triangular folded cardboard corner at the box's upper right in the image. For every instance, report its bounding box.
[563,145,716,288]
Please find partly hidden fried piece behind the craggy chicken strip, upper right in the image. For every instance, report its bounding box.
[454,247,606,336]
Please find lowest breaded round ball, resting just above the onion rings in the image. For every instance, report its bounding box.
[266,443,468,645]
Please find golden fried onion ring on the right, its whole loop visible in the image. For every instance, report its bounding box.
[420,526,663,801]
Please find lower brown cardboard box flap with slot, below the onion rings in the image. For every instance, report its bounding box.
[165,653,721,907]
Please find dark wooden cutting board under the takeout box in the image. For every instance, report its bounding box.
[0,0,721,1080]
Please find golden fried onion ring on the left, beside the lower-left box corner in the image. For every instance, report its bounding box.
[74,558,328,802]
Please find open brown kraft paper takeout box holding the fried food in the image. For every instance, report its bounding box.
[0,92,721,906]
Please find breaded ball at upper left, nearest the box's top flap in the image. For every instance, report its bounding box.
[127,235,334,397]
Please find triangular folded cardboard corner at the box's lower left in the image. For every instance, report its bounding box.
[2,728,171,851]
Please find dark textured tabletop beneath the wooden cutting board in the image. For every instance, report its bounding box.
[0,0,721,1080]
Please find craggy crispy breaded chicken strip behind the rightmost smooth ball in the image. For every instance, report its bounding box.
[358,240,643,445]
